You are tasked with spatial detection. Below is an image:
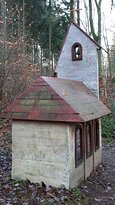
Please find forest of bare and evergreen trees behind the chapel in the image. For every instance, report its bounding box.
[0,0,115,137]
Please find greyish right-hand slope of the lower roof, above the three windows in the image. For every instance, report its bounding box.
[43,77,111,121]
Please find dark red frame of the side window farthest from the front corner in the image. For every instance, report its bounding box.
[94,119,100,151]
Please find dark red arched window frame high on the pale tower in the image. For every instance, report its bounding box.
[72,42,83,61]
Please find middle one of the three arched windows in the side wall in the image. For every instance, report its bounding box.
[86,123,92,158]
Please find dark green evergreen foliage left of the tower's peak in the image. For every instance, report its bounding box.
[7,0,70,65]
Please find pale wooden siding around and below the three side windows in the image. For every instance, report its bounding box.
[68,124,97,188]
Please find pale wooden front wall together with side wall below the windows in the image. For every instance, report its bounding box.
[12,121,101,188]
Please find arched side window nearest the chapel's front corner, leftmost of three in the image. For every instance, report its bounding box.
[75,126,83,167]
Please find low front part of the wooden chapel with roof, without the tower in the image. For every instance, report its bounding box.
[2,77,110,188]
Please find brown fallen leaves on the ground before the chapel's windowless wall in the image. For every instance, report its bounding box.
[0,150,89,205]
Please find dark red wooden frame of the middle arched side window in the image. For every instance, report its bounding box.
[86,122,93,159]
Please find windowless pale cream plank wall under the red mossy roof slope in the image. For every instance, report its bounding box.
[12,121,69,188]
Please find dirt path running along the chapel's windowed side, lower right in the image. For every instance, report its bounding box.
[80,142,115,205]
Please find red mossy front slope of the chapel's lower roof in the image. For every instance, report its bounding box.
[1,78,84,122]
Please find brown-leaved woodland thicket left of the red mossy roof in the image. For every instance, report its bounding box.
[0,0,39,107]
